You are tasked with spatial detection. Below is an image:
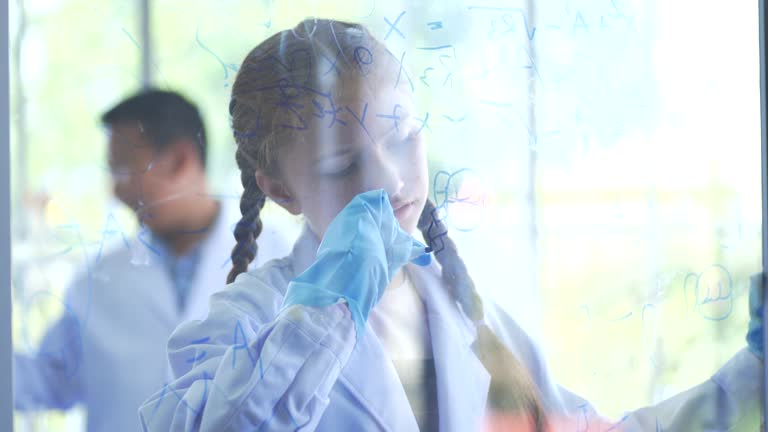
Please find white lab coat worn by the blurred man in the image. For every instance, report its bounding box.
[14,202,292,431]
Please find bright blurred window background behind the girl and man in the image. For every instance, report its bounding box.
[8,0,761,431]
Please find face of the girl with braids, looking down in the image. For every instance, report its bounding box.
[257,87,428,238]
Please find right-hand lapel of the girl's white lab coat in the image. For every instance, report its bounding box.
[407,262,491,431]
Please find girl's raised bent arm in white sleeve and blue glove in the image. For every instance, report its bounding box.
[140,191,432,431]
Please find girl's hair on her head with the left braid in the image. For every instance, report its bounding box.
[227,20,373,283]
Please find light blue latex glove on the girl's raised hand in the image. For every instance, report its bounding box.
[283,189,431,340]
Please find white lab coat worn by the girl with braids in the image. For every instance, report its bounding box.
[140,229,761,432]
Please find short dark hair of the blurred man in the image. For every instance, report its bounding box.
[101,89,207,167]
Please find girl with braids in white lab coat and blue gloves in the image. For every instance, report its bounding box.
[140,20,759,432]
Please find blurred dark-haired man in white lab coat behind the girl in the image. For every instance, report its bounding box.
[14,90,292,431]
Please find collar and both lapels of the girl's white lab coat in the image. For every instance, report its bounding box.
[284,225,491,431]
